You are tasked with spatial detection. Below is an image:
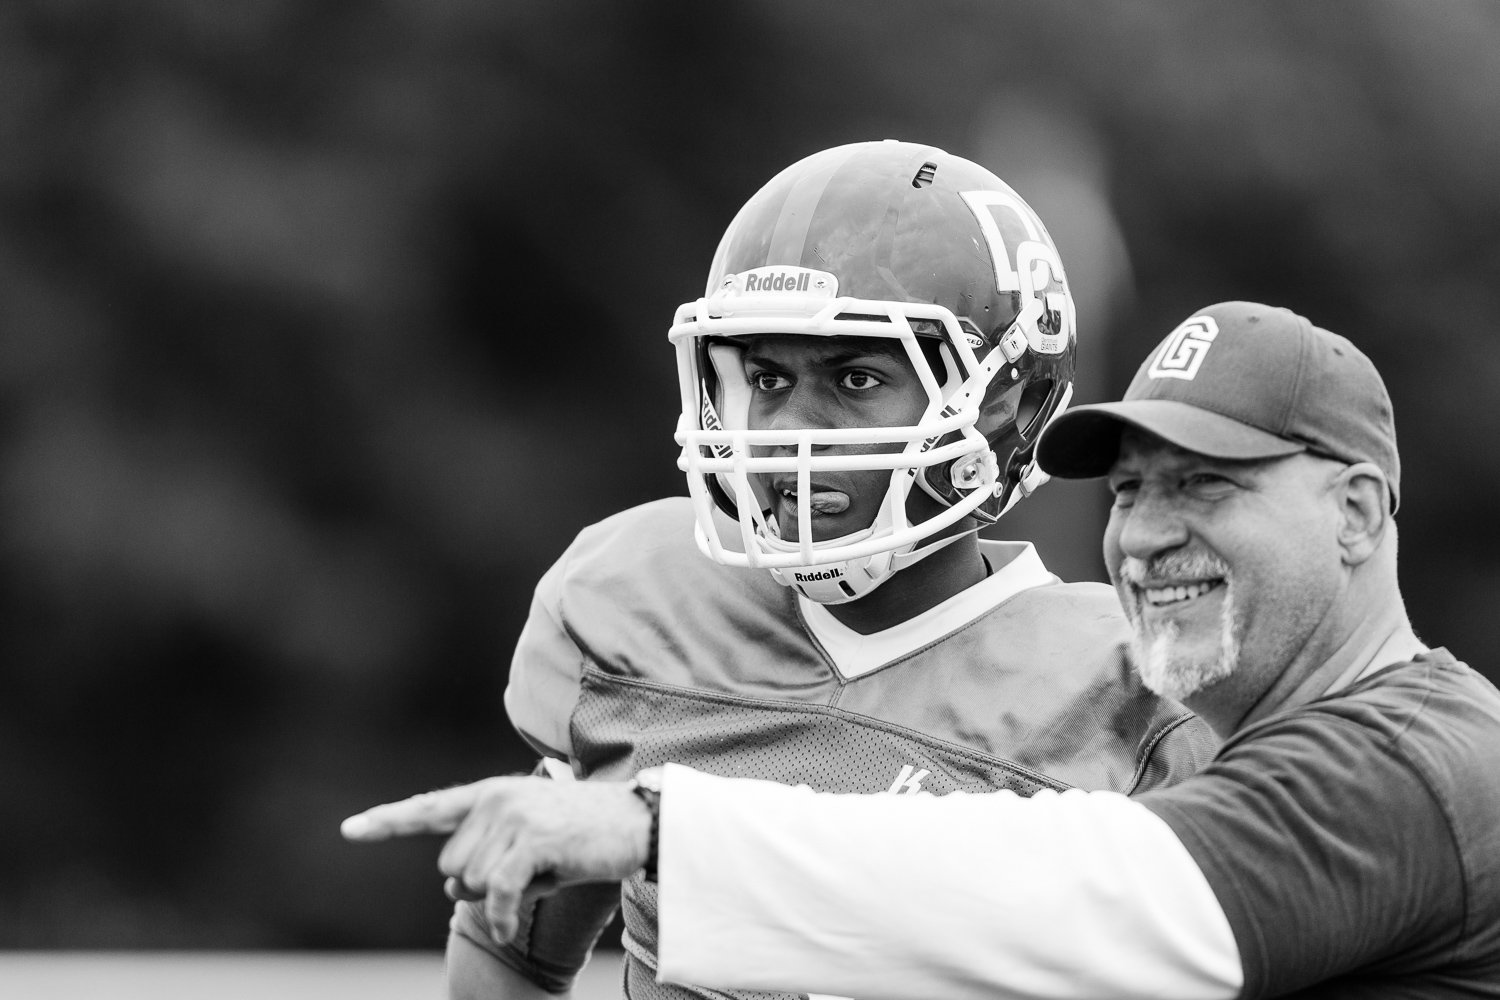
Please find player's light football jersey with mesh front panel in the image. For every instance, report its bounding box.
[492,499,1217,999]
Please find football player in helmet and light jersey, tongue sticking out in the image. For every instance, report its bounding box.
[435,141,1215,999]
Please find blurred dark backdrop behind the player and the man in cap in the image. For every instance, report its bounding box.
[0,0,1500,948]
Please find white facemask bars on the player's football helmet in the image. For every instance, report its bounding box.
[672,277,1004,603]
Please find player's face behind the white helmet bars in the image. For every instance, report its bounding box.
[744,334,929,541]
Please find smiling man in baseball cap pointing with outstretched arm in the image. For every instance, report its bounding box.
[347,303,1500,1000]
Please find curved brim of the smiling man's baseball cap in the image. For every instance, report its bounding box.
[1037,399,1307,480]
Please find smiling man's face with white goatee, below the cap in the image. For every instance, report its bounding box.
[1104,429,1347,715]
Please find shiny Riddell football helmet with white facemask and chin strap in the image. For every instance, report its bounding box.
[669,139,1077,604]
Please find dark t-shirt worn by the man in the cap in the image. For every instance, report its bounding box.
[1137,649,1500,999]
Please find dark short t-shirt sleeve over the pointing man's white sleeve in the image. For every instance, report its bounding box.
[1136,714,1463,997]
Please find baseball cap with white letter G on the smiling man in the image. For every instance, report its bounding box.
[1037,301,1401,508]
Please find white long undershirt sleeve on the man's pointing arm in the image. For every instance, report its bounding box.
[657,765,1244,1000]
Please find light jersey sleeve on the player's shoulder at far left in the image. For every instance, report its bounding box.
[506,553,584,760]
